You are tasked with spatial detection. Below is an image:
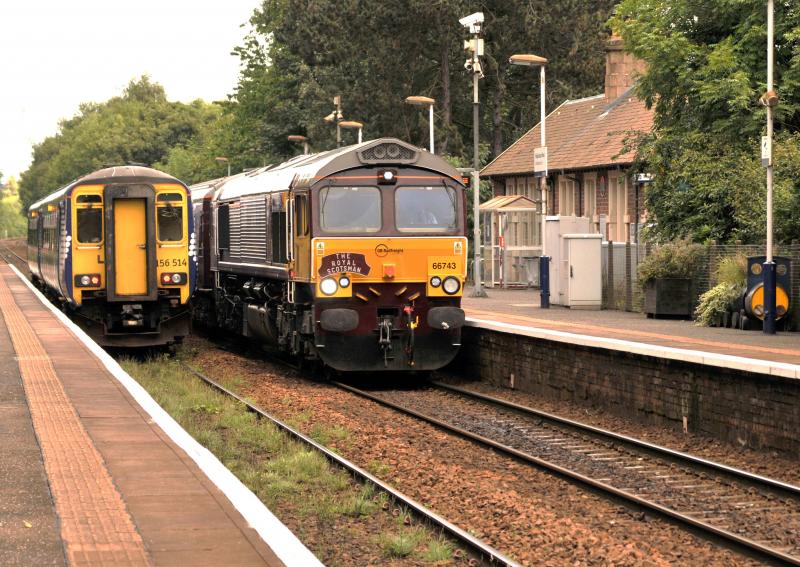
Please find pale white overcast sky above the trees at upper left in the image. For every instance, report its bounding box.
[0,0,260,179]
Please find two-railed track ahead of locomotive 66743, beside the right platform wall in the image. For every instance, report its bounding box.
[335,382,800,565]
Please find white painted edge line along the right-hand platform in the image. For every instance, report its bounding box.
[467,317,800,378]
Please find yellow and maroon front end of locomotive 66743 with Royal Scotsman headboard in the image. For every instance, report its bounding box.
[300,166,467,371]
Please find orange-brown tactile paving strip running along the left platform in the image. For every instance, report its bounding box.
[0,277,151,567]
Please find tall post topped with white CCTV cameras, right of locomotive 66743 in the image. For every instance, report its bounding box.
[459,12,486,297]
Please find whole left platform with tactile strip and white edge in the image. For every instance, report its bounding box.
[0,262,320,567]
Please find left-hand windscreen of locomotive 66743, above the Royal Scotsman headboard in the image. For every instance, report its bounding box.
[319,186,382,233]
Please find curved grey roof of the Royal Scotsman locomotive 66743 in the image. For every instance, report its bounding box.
[190,138,461,204]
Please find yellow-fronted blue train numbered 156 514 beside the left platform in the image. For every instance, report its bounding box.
[28,165,197,347]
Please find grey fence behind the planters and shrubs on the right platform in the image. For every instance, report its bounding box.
[602,242,800,327]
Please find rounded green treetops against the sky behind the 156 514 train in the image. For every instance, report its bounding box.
[20,76,220,208]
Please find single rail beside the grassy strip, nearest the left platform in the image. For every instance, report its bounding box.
[185,365,521,567]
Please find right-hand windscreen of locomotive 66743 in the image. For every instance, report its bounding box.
[394,185,457,232]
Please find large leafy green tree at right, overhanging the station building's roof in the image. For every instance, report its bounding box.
[611,0,800,243]
